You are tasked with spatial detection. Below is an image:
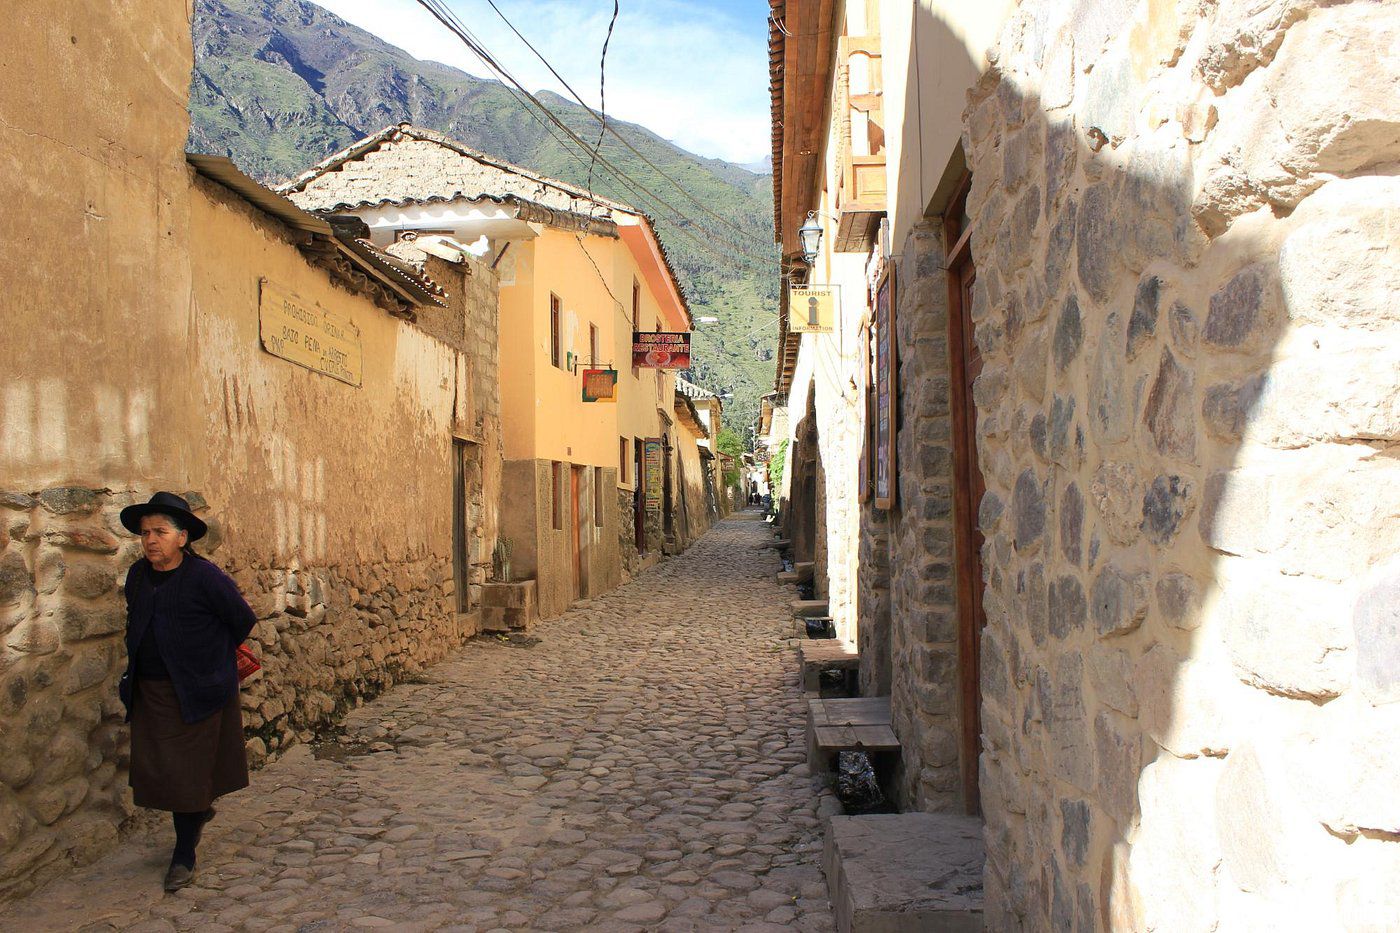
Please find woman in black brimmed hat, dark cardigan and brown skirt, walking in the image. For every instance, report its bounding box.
[120,492,256,891]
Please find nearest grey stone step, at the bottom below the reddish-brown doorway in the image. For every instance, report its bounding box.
[822,813,986,933]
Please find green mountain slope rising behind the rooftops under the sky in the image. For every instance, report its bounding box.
[190,0,777,433]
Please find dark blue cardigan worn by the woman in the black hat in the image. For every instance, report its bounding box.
[120,555,258,723]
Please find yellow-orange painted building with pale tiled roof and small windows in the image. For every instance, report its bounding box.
[286,123,693,618]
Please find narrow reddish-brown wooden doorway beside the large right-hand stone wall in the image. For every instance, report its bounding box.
[944,175,987,815]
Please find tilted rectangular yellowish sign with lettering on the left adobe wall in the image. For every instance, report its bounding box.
[258,279,364,385]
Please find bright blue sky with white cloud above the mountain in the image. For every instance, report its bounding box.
[303,0,769,163]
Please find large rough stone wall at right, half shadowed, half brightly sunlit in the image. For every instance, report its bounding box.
[963,0,1400,930]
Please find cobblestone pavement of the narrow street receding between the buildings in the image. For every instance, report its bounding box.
[0,520,833,933]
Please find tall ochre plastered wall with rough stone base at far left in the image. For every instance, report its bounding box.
[0,0,202,898]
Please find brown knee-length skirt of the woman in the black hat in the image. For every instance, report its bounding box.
[132,679,248,813]
